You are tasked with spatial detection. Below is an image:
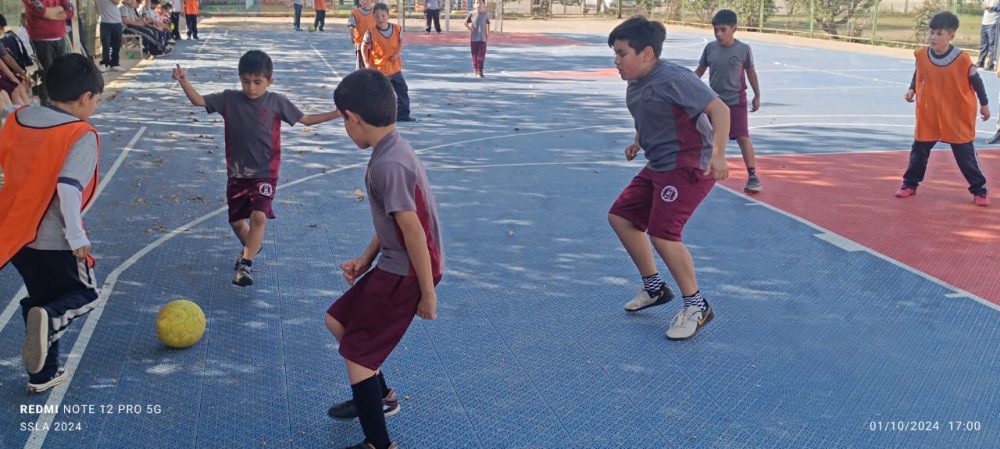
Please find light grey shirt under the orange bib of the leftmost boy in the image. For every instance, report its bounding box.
[17,106,97,250]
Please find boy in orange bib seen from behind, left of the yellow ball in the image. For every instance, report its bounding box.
[0,53,104,393]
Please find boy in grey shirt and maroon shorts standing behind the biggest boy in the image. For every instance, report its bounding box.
[694,9,762,195]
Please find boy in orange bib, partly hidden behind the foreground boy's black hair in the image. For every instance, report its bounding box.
[361,0,417,122]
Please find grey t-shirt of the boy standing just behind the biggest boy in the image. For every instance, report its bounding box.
[698,40,753,105]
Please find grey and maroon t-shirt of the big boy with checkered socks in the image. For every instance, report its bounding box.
[625,60,716,171]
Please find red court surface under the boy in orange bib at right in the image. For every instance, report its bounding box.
[724,149,1000,305]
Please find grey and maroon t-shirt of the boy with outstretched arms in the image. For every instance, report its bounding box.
[203,90,305,179]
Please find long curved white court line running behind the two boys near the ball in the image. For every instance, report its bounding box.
[24,126,604,449]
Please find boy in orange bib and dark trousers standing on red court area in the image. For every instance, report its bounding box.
[896,11,990,207]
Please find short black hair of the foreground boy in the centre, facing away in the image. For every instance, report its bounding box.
[333,69,396,126]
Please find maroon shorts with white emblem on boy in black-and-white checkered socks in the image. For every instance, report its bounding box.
[608,167,715,242]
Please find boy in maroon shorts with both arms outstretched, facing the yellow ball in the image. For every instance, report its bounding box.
[174,50,340,287]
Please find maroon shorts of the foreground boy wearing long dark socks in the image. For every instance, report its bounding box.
[326,268,441,370]
